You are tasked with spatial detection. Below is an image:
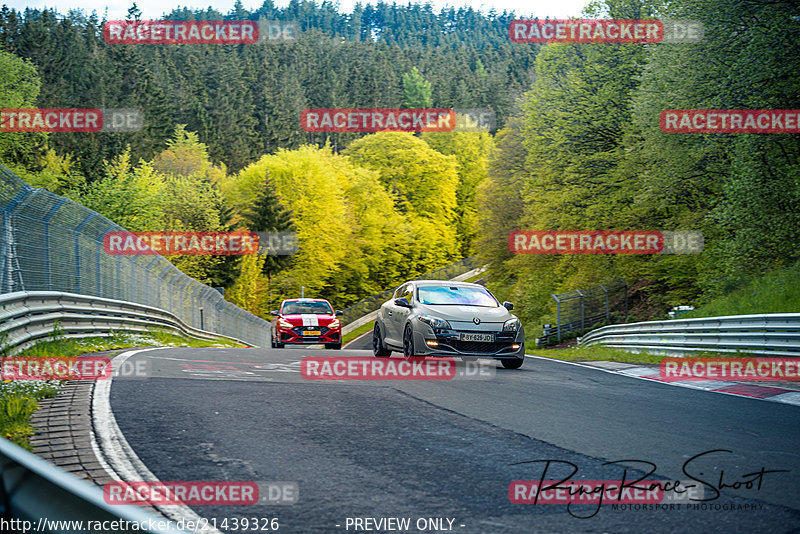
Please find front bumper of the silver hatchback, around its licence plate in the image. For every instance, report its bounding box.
[414,328,525,360]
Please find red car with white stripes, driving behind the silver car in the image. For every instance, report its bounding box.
[270,299,342,349]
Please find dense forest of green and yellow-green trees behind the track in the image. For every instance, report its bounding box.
[0,0,800,328]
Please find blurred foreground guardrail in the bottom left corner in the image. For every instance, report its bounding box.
[0,438,184,534]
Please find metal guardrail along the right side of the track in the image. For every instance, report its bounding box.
[578,313,800,356]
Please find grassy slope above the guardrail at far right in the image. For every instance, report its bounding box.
[681,263,800,319]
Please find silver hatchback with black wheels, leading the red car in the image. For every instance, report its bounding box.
[372,280,525,369]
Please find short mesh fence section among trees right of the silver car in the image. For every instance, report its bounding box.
[536,278,628,346]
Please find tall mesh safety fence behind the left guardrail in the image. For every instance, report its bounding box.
[0,165,269,347]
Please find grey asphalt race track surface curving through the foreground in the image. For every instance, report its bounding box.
[110,348,800,534]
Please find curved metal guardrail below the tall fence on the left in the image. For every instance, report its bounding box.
[0,291,250,354]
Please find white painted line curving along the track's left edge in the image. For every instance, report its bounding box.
[92,347,222,534]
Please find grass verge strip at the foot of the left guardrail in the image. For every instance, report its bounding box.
[0,323,241,450]
